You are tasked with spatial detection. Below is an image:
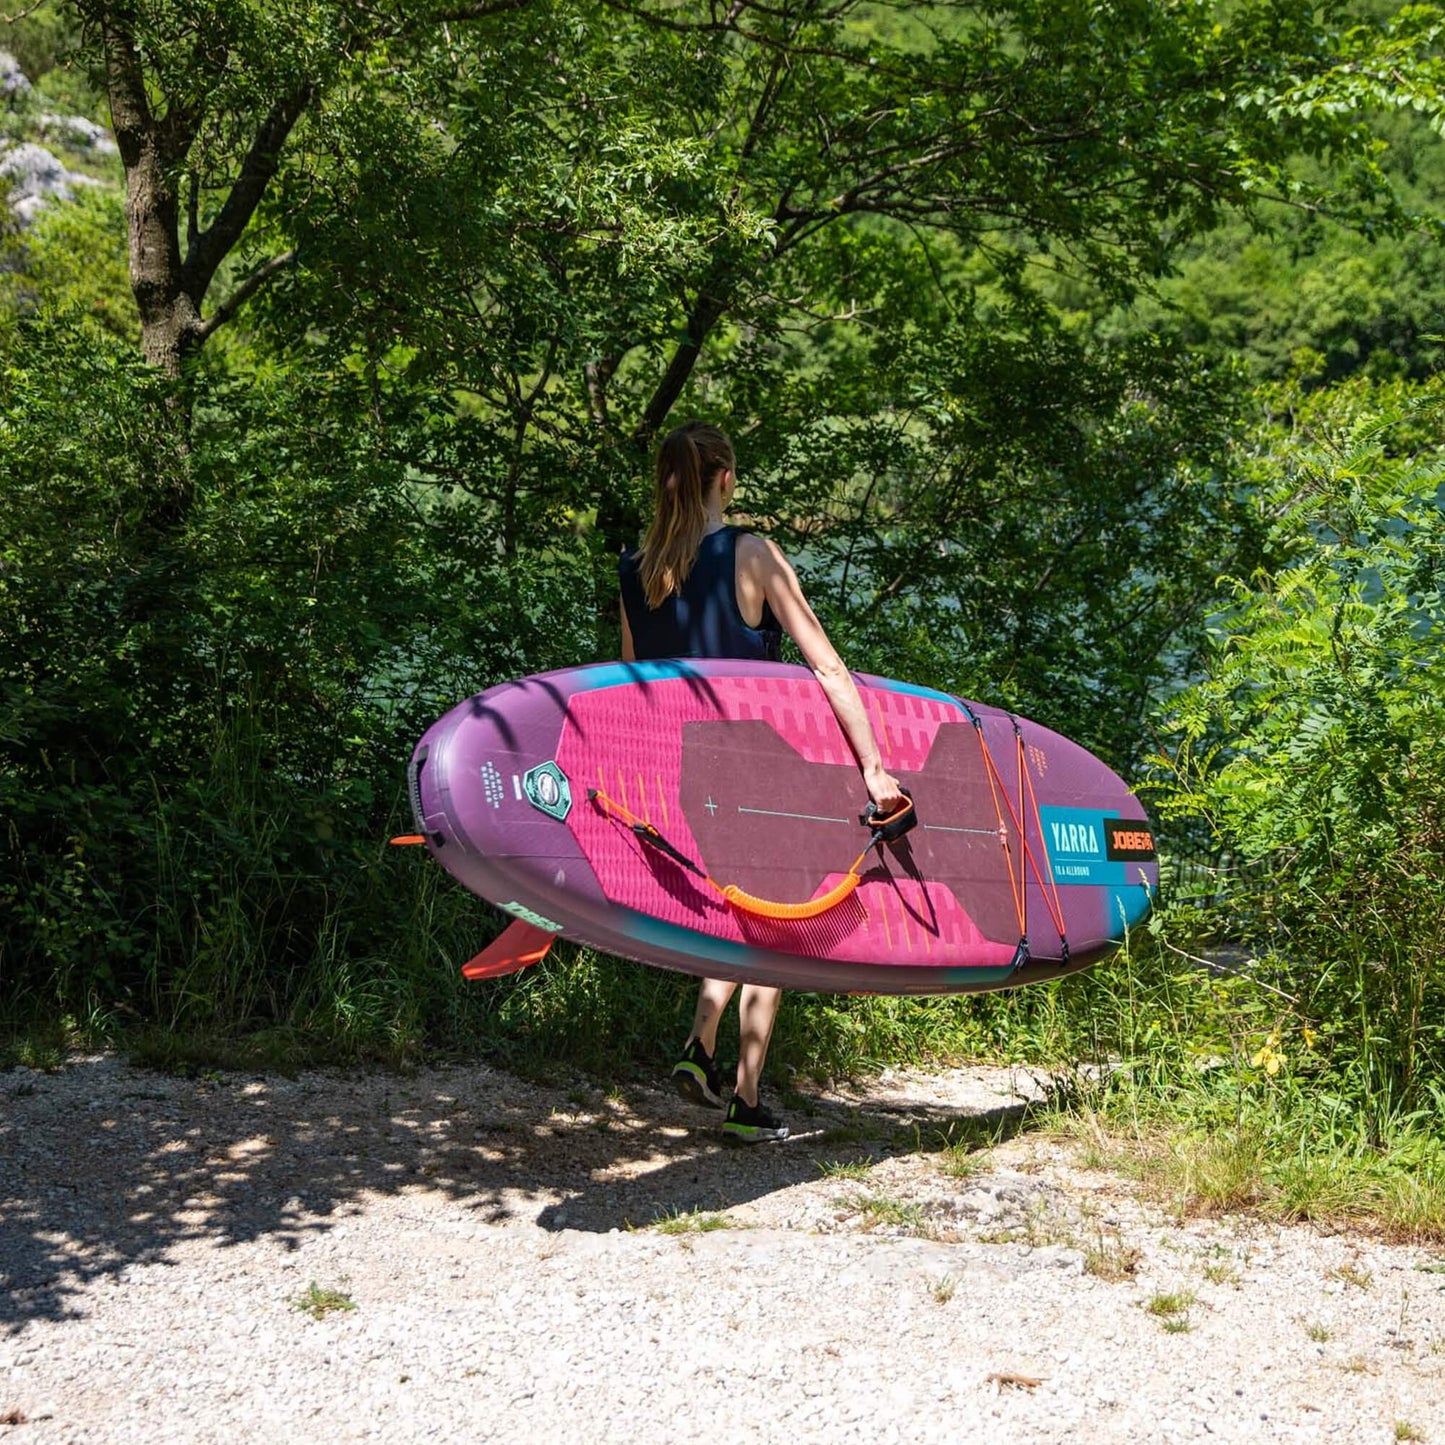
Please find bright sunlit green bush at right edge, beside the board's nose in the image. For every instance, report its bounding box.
[1162,383,1445,1130]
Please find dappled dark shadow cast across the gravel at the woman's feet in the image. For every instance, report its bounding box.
[0,1058,1033,1329]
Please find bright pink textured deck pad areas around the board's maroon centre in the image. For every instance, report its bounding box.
[556,678,1013,965]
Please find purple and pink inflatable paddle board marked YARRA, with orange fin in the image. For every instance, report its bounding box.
[397,660,1159,994]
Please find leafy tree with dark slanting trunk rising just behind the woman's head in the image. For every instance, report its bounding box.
[234,0,1435,608]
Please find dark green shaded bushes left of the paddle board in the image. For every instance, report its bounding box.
[0,324,577,1043]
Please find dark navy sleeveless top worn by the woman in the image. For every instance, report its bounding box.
[617,527,783,662]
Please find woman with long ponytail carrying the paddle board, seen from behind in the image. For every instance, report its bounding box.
[620,422,902,1143]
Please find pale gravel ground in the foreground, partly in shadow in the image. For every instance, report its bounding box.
[0,1056,1445,1445]
